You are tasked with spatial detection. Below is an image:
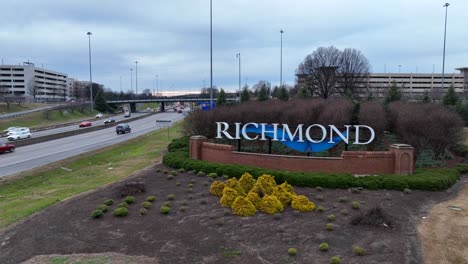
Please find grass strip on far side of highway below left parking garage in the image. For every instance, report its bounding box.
[0,110,97,131]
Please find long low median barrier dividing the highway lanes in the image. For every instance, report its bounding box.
[8,112,156,147]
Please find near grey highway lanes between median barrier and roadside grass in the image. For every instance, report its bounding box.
[0,109,184,177]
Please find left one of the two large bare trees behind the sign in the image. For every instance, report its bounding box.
[296,46,341,98]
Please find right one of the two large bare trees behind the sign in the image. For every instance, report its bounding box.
[338,48,370,96]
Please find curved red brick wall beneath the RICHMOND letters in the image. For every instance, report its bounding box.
[190,136,414,174]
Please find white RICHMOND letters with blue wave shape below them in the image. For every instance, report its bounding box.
[216,122,375,152]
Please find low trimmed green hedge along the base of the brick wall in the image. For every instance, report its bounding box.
[163,137,462,191]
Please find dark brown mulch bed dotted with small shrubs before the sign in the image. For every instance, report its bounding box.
[0,167,466,264]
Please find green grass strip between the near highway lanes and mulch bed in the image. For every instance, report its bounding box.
[0,123,181,229]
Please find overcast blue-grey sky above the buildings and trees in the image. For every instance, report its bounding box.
[0,0,468,92]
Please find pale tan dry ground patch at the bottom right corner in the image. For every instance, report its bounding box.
[418,179,468,264]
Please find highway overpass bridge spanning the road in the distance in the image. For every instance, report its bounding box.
[106,96,236,112]
